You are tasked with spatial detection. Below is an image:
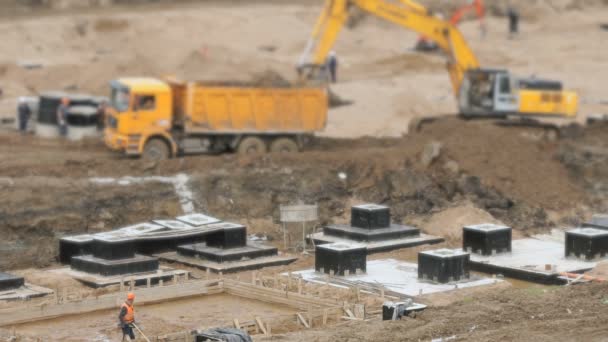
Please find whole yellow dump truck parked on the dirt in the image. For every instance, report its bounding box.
[104,78,328,159]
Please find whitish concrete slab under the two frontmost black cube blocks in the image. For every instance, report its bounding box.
[292,259,501,297]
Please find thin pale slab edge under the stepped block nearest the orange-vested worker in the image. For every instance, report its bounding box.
[46,266,190,288]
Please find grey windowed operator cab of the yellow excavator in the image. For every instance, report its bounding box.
[459,69,519,117]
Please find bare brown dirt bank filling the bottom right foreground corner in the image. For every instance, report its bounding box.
[264,284,608,342]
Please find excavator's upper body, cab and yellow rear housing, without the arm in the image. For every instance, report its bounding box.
[458,69,578,117]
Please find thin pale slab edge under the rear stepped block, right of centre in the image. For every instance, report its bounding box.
[308,232,444,254]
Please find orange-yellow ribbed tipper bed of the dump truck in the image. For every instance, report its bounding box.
[172,82,328,134]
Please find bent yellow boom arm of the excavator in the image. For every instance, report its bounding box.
[299,0,479,96]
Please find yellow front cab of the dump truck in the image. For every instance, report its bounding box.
[105,78,176,155]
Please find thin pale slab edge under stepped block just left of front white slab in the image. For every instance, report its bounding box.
[154,252,298,273]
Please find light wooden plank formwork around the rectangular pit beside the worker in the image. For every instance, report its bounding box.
[0,273,365,342]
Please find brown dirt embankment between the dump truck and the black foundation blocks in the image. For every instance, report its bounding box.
[0,117,607,269]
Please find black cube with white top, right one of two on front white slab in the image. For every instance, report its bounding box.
[418,249,469,284]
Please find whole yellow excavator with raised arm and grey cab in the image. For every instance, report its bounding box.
[298,0,578,118]
